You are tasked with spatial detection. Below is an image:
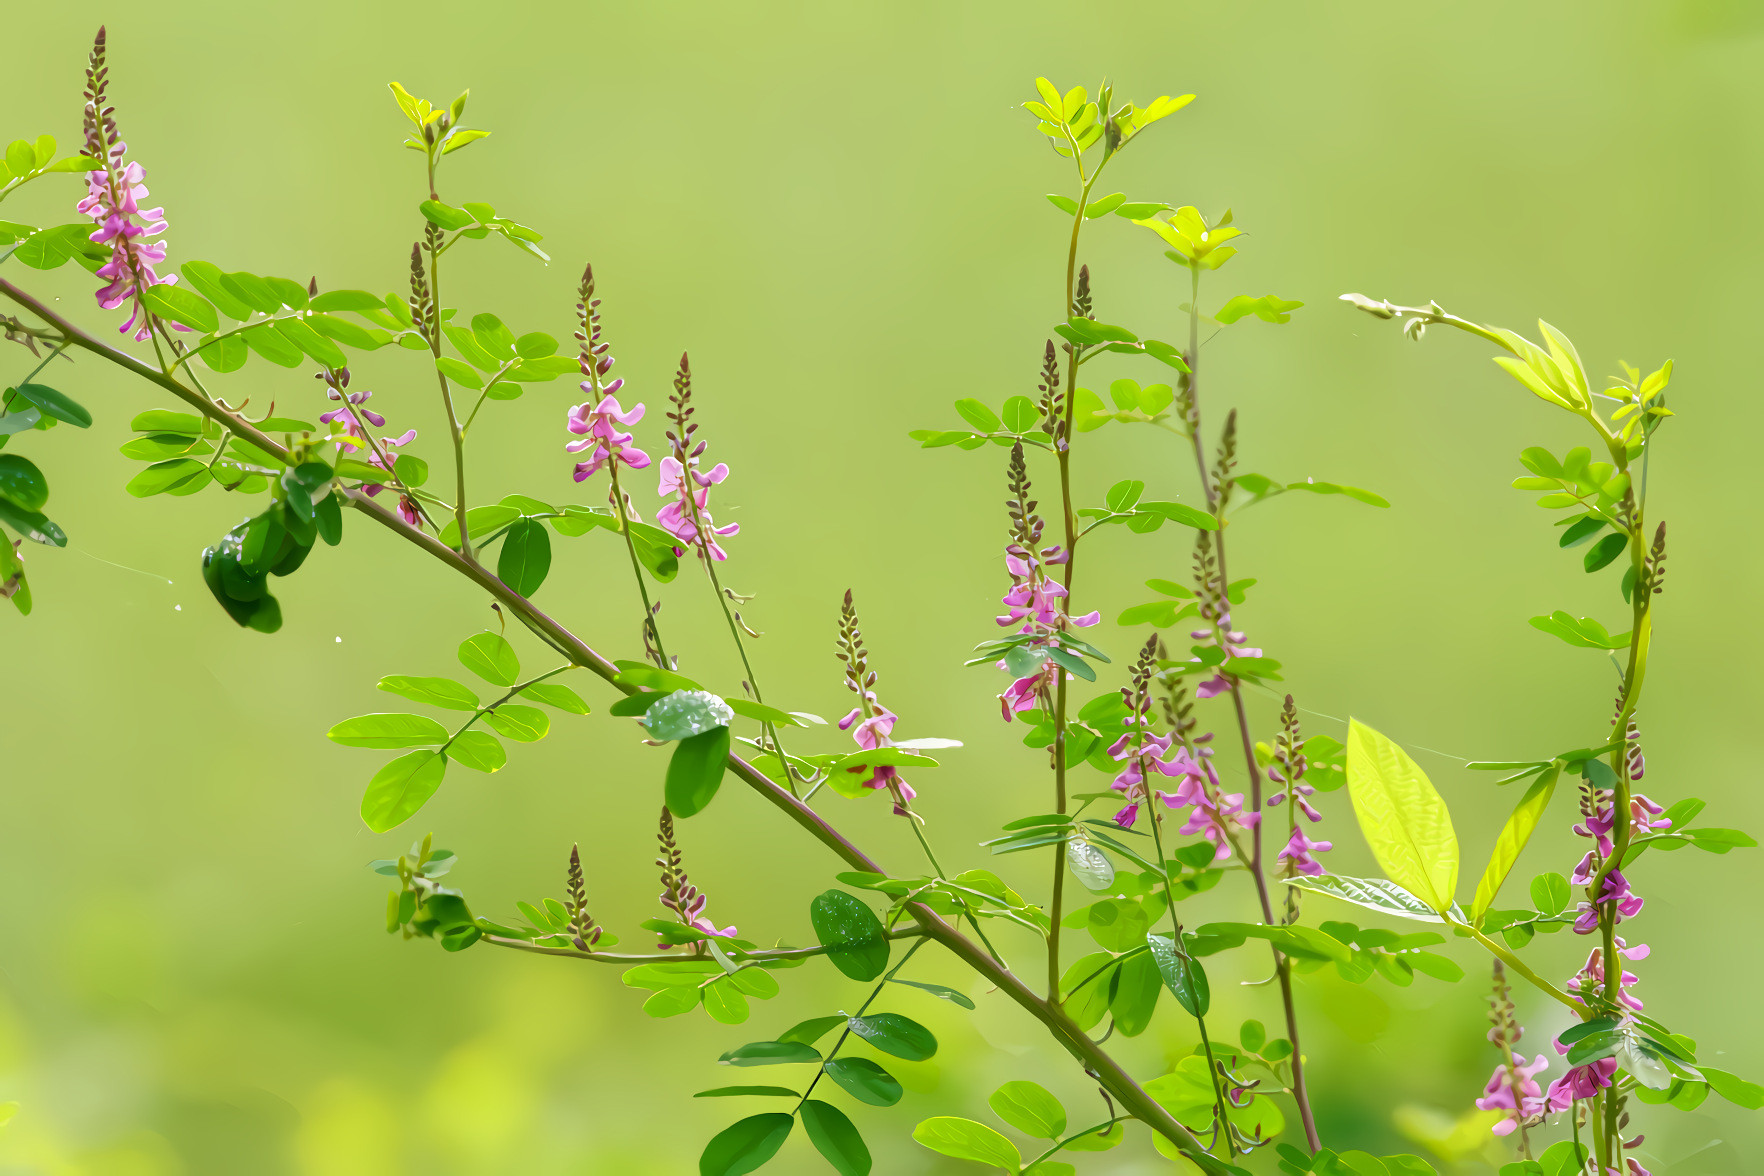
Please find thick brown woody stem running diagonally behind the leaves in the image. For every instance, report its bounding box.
[0,279,1228,1176]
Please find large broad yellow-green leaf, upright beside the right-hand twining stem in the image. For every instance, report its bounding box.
[1348,719,1457,913]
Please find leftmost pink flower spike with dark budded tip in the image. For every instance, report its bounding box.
[76,28,176,342]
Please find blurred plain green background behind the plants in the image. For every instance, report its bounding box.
[0,0,1764,1176]
